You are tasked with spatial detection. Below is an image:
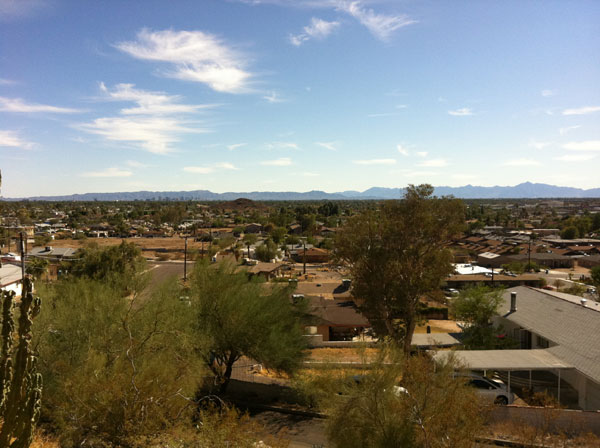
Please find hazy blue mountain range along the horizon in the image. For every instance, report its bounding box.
[2,182,600,201]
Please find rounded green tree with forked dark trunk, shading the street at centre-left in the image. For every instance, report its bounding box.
[188,263,305,393]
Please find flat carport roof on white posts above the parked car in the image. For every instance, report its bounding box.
[433,349,574,402]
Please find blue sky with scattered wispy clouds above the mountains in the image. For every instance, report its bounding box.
[0,0,600,197]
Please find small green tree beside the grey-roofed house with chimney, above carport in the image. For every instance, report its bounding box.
[452,286,514,350]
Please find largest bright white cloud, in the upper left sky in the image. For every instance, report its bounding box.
[116,29,252,93]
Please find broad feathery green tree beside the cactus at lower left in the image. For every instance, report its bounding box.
[34,278,203,447]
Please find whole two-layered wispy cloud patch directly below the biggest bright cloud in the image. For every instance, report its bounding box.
[75,84,207,154]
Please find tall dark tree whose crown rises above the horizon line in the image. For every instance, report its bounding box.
[335,185,464,353]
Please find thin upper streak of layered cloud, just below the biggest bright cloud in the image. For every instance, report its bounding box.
[100,83,212,115]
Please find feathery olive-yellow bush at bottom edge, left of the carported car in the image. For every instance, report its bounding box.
[310,355,482,448]
